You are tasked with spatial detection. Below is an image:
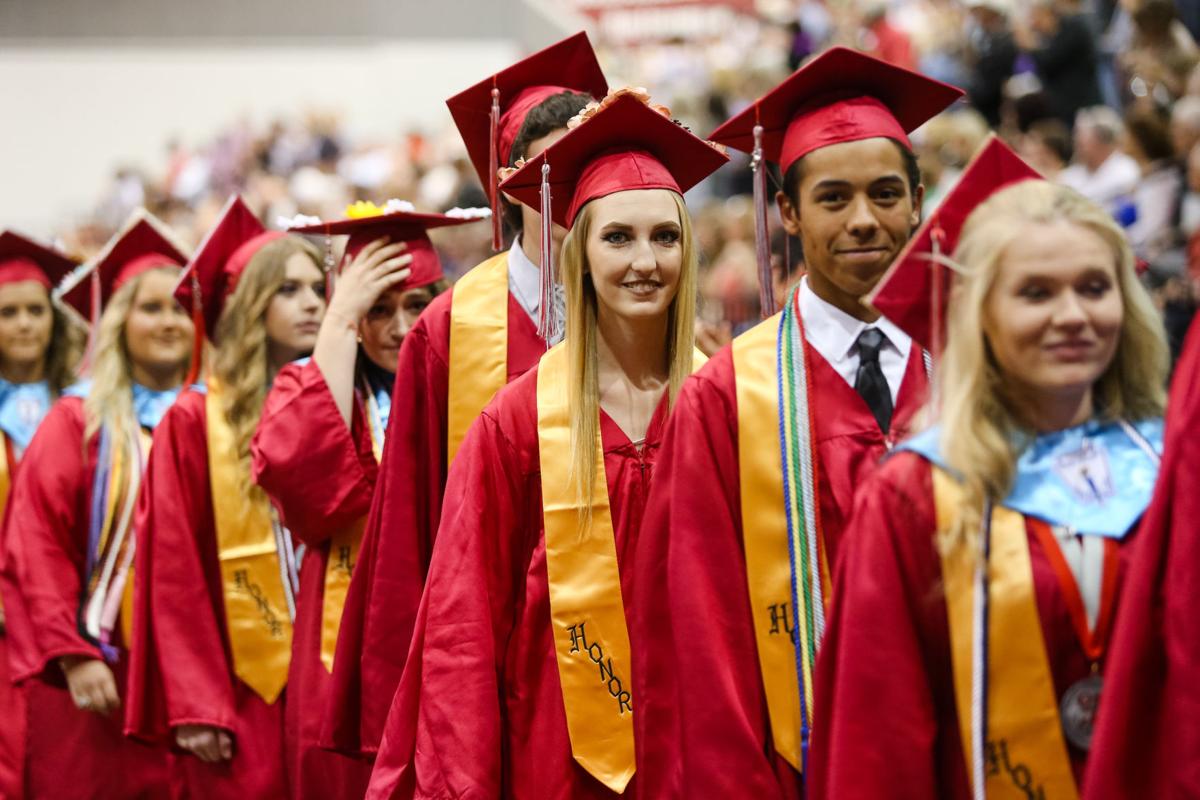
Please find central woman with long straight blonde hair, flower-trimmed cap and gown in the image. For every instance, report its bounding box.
[368,90,727,800]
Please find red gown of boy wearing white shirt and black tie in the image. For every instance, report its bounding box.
[630,344,928,799]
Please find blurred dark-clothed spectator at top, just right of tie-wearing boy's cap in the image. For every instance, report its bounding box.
[966,0,1016,127]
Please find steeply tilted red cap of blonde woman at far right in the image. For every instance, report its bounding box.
[866,134,1042,356]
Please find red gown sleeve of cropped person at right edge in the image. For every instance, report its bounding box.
[1087,324,1200,800]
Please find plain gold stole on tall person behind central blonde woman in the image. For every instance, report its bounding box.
[446,253,509,469]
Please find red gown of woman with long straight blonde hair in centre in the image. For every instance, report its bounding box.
[367,369,667,800]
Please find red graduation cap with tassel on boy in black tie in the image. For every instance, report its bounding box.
[709,47,962,315]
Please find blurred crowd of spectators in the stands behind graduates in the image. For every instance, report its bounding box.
[60,0,1200,352]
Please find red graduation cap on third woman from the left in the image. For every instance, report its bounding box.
[175,194,286,341]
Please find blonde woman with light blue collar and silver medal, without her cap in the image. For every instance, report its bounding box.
[812,176,1168,799]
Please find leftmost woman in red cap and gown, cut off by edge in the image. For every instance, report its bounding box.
[0,230,83,798]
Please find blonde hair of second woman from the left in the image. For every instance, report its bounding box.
[83,266,191,443]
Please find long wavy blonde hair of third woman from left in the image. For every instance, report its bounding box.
[212,235,322,498]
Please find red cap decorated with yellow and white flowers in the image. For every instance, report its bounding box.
[288,200,491,290]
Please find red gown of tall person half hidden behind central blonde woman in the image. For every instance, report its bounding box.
[323,290,546,753]
